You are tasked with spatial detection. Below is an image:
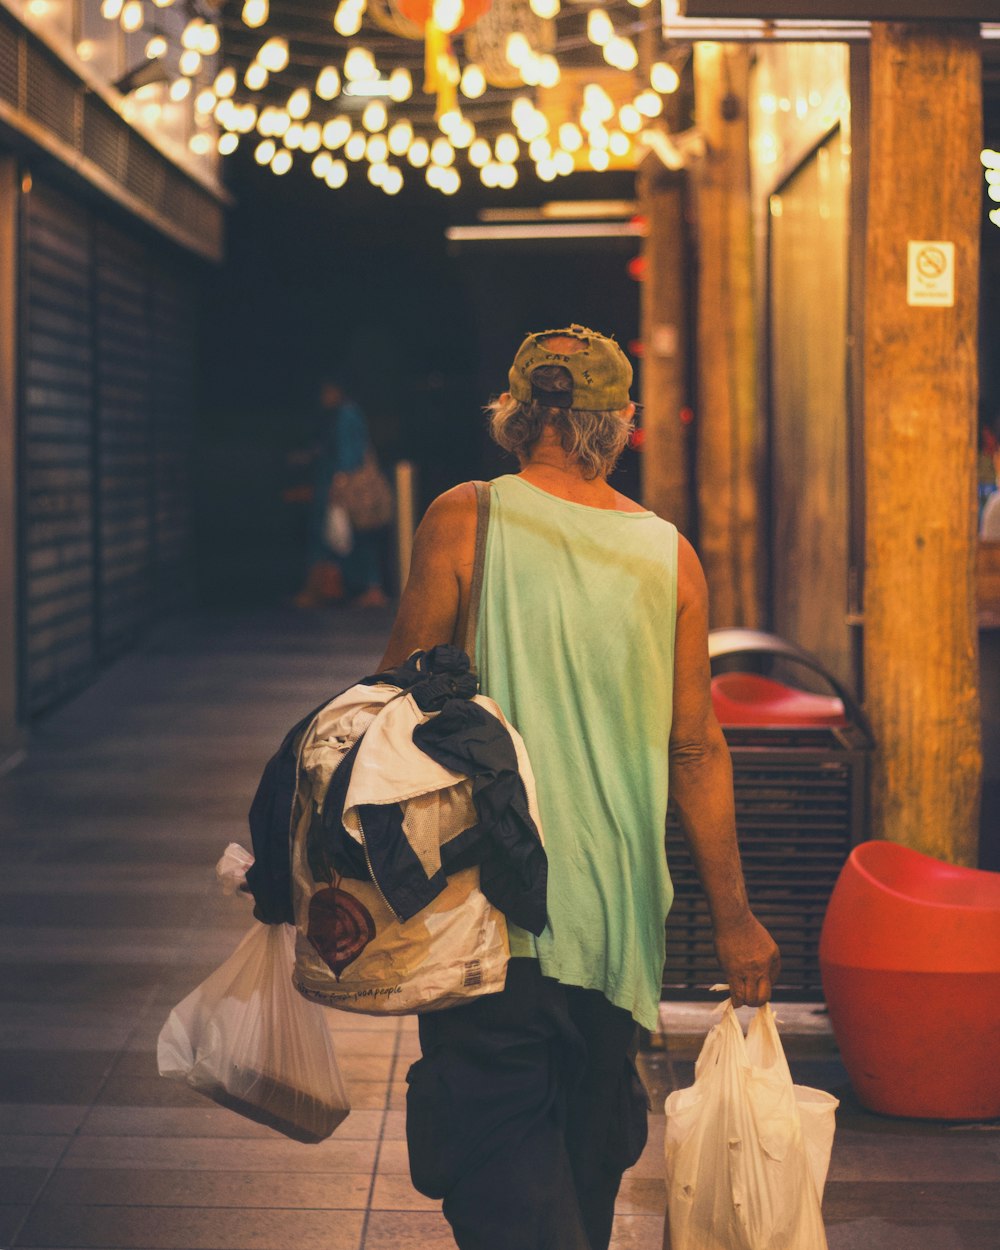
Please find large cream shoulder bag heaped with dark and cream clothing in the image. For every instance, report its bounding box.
[246,646,546,1015]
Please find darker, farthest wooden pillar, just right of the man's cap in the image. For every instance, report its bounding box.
[639,156,691,538]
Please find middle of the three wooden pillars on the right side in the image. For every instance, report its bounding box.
[694,43,760,626]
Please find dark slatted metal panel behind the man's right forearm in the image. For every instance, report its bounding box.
[664,729,866,1000]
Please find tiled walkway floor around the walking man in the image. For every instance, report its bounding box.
[0,613,1000,1250]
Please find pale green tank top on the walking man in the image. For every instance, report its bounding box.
[476,475,678,1029]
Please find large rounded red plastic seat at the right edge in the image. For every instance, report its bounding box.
[820,841,1000,1120]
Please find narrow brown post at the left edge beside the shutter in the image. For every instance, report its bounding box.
[0,156,19,768]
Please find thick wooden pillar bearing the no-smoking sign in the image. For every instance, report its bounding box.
[864,23,983,864]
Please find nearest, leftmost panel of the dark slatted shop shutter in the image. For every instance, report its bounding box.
[20,184,96,716]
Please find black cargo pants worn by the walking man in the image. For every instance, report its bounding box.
[406,959,649,1250]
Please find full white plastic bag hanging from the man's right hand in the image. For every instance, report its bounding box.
[664,1001,838,1250]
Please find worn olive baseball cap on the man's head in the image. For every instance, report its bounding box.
[509,324,633,413]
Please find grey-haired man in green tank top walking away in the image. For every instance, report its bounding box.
[381,325,780,1250]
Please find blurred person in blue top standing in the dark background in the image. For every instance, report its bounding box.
[293,378,389,609]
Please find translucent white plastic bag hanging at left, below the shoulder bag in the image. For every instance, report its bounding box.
[156,923,350,1143]
